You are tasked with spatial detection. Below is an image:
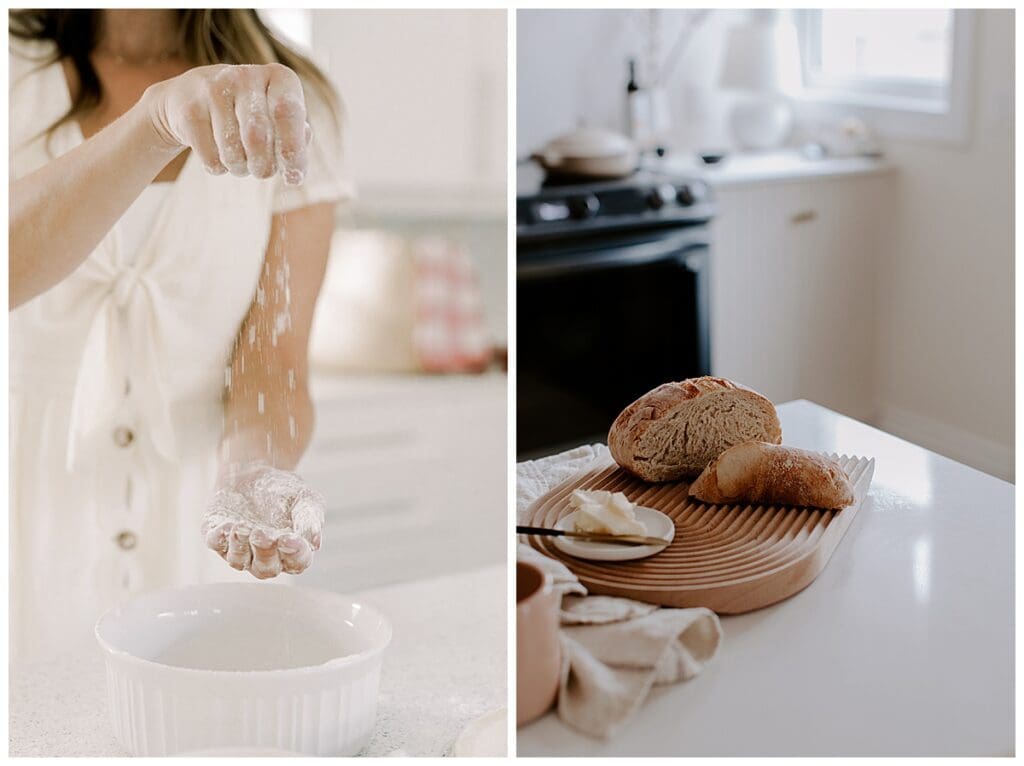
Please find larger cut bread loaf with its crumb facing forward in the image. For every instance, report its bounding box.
[608,377,782,481]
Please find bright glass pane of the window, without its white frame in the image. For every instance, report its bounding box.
[819,9,952,83]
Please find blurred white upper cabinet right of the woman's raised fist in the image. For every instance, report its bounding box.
[312,9,508,215]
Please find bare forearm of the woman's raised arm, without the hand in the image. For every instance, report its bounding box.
[7,101,183,308]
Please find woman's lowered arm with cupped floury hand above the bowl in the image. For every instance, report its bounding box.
[203,204,334,579]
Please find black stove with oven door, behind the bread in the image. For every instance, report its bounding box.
[516,162,715,459]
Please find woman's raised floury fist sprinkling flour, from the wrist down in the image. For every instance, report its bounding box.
[142,63,312,184]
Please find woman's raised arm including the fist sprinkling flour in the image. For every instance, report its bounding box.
[7,65,309,308]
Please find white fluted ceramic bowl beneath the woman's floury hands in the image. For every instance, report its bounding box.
[96,583,391,756]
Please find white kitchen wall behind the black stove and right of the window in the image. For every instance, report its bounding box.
[516,10,1014,478]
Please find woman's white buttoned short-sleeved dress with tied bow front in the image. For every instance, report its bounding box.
[9,38,350,658]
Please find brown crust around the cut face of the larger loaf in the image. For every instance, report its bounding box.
[608,375,782,481]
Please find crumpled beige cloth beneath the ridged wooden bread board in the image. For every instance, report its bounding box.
[516,444,722,738]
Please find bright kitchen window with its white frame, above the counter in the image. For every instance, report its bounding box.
[794,9,973,142]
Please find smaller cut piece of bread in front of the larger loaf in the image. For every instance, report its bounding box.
[690,441,853,509]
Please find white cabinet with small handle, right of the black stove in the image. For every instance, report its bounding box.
[709,164,892,419]
